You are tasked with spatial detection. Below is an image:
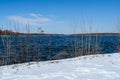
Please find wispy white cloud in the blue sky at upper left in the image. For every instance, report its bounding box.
[8,13,52,25]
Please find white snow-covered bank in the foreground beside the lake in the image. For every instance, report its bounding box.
[0,53,120,80]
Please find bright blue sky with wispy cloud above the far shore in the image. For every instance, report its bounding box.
[0,0,120,34]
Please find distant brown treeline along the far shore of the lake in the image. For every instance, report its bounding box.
[0,29,120,36]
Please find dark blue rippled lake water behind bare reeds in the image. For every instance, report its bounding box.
[0,35,120,64]
